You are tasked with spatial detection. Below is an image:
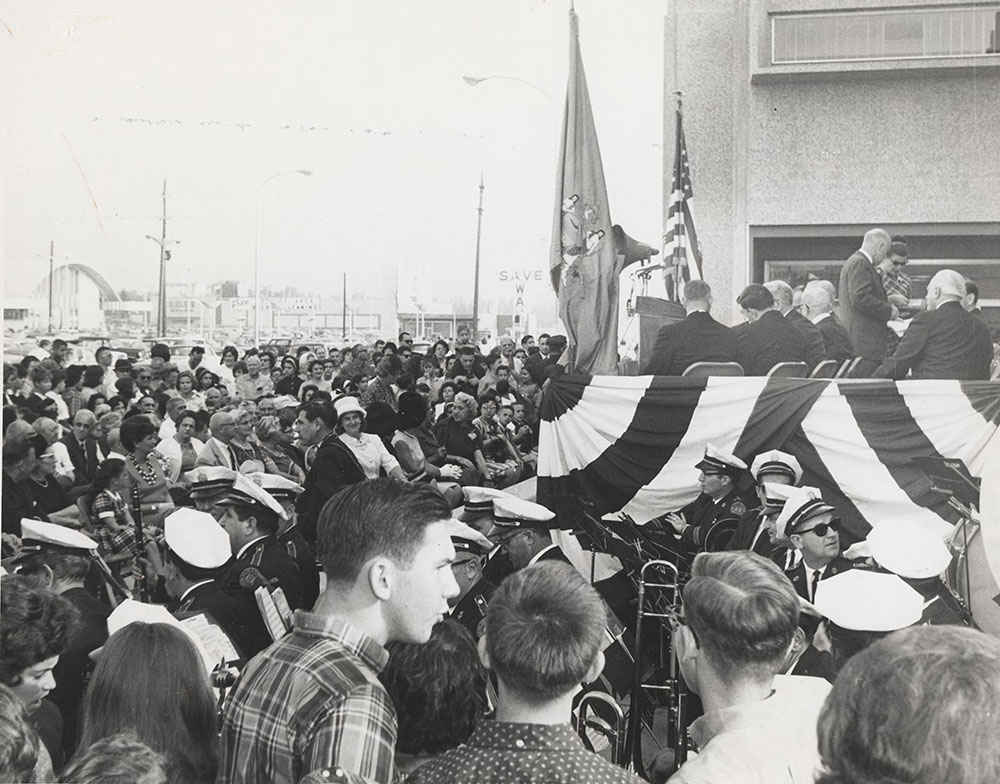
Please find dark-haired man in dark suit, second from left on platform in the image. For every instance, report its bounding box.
[736,283,806,376]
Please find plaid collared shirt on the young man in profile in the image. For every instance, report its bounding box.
[217,610,396,784]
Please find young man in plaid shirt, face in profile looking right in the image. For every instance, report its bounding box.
[218,479,458,784]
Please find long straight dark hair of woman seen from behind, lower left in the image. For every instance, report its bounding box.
[80,623,218,784]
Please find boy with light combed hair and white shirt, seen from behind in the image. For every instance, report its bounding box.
[670,552,830,784]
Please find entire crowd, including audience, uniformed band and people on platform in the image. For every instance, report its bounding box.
[0,230,1000,784]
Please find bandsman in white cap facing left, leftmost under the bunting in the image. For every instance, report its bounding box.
[652,444,752,554]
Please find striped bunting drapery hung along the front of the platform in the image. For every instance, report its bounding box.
[538,376,1000,541]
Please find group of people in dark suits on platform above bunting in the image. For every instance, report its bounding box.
[644,229,1000,381]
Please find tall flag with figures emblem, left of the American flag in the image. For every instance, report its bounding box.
[549,8,621,375]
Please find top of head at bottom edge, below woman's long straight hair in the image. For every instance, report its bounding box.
[59,732,168,784]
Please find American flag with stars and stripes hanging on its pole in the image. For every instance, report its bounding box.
[663,106,702,302]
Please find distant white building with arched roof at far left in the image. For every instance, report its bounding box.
[32,264,121,330]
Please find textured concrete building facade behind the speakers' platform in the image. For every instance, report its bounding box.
[664,0,1000,326]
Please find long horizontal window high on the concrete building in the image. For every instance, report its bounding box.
[771,3,1000,65]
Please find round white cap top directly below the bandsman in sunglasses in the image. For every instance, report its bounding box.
[813,569,924,632]
